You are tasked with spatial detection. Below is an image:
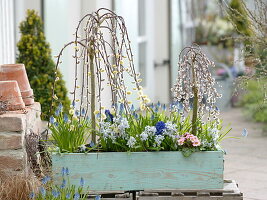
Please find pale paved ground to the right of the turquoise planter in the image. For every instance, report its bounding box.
[221,108,267,200]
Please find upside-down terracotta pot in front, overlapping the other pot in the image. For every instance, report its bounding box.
[0,81,25,110]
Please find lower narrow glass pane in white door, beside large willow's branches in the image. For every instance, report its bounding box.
[138,42,146,86]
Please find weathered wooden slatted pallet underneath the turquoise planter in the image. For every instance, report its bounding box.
[89,180,243,200]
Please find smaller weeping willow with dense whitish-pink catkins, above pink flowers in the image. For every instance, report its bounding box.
[172,46,221,135]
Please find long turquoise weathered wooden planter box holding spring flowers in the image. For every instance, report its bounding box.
[52,151,224,191]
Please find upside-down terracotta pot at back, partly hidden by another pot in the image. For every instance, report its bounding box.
[0,64,34,105]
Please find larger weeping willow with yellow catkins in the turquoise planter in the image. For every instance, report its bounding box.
[51,8,148,142]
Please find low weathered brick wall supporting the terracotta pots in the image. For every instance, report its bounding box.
[0,102,42,173]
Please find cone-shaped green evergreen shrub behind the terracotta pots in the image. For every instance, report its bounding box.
[17,10,70,120]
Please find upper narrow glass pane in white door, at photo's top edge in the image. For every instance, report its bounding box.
[138,0,146,36]
